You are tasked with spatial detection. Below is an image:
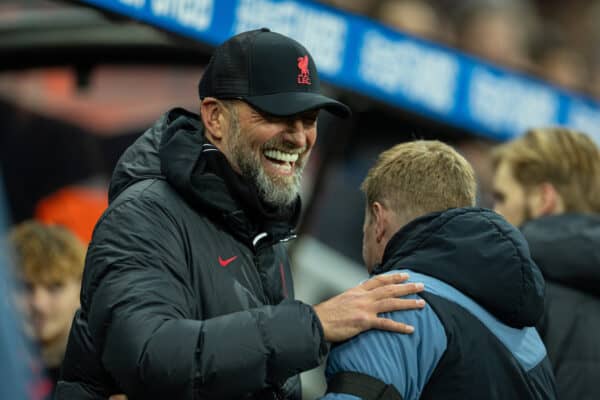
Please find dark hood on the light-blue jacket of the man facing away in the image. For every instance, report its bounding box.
[375,208,544,328]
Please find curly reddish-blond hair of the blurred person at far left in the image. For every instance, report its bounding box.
[9,221,86,285]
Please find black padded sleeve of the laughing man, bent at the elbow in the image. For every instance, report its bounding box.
[82,193,327,399]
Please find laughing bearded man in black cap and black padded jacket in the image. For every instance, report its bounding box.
[57,29,421,399]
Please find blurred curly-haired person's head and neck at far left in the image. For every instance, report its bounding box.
[9,221,85,398]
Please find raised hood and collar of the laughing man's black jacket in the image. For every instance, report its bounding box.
[110,108,301,248]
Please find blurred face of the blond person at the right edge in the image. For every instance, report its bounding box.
[493,161,531,226]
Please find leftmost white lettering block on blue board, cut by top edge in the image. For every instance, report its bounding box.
[151,0,214,31]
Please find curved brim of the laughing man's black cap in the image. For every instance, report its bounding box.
[244,92,351,118]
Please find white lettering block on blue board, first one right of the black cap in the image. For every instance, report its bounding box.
[358,31,459,113]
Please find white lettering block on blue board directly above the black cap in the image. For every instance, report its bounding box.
[233,0,348,75]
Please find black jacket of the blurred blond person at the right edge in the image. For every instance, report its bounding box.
[521,214,600,400]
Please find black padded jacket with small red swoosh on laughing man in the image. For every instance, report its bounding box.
[57,109,328,400]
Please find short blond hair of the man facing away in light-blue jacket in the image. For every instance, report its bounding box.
[361,140,477,220]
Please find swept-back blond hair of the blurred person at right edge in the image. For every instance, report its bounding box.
[492,127,600,212]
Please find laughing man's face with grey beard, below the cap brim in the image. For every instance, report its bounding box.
[222,101,318,207]
